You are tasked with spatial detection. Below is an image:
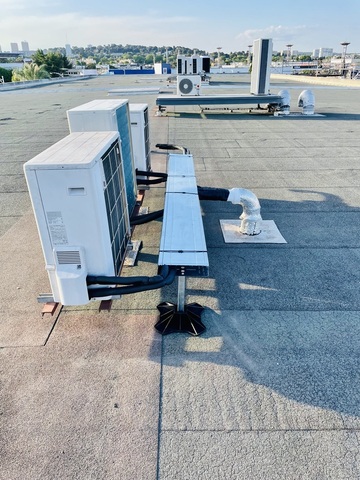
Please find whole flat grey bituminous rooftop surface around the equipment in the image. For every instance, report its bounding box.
[0,75,360,480]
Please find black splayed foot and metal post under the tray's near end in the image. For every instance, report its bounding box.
[155,276,206,336]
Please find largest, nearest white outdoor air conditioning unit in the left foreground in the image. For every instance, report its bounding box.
[24,132,130,305]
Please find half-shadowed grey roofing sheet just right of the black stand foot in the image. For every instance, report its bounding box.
[162,309,360,431]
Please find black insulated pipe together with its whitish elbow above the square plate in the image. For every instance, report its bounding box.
[198,187,262,235]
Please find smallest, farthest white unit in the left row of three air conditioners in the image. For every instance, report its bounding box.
[129,103,151,171]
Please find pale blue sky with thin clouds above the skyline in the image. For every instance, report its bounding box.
[0,0,360,52]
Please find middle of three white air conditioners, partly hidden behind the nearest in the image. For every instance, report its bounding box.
[67,99,137,216]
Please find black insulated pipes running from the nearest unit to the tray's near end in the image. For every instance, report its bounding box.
[87,265,176,299]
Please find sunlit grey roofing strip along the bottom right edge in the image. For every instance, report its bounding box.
[160,431,360,480]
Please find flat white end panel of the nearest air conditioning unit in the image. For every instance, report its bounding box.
[36,168,115,275]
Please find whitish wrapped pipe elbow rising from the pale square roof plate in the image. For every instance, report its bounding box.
[227,188,262,235]
